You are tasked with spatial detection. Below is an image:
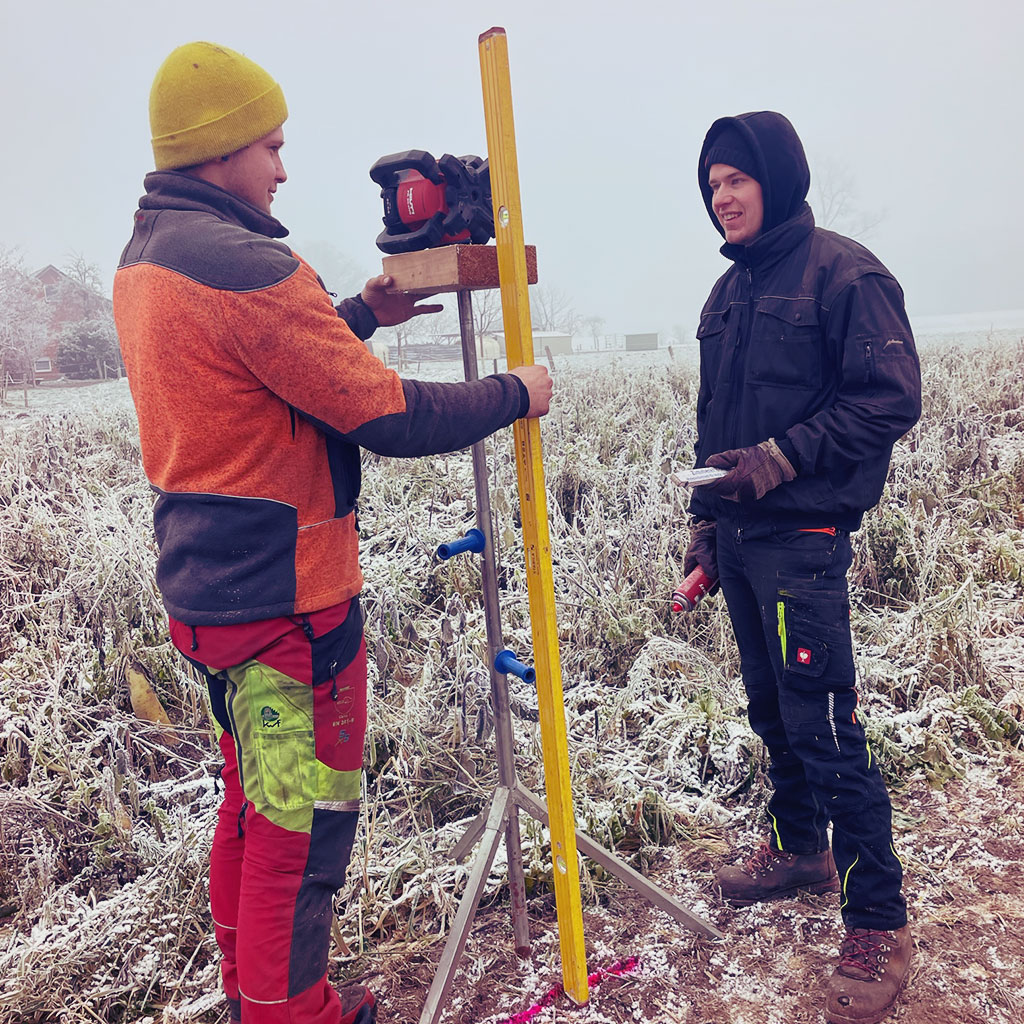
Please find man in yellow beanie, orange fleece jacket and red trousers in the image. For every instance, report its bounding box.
[114,42,551,1024]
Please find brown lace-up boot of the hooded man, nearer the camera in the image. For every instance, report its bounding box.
[827,925,913,1024]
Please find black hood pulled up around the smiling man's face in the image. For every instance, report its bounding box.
[697,111,811,238]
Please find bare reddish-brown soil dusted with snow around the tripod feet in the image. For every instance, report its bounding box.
[346,758,1024,1024]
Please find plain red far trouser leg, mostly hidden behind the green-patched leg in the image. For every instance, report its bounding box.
[210,732,246,1020]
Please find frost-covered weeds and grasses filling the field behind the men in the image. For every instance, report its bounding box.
[0,339,1024,1024]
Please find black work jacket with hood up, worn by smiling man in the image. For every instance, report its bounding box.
[690,111,921,529]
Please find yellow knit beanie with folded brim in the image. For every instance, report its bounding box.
[150,42,288,171]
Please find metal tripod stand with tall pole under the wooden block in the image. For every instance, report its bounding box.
[420,289,724,1024]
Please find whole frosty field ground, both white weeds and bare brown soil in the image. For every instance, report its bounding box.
[0,331,1024,1024]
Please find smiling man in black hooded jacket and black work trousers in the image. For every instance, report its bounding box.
[685,112,921,1024]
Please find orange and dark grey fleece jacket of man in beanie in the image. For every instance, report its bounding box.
[114,171,529,626]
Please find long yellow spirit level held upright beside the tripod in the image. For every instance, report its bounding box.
[479,29,590,1004]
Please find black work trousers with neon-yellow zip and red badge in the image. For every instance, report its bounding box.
[718,520,906,930]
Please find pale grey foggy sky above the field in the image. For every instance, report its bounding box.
[0,0,1024,335]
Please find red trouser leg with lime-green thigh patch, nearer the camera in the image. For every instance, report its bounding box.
[218,626,366,1024]
